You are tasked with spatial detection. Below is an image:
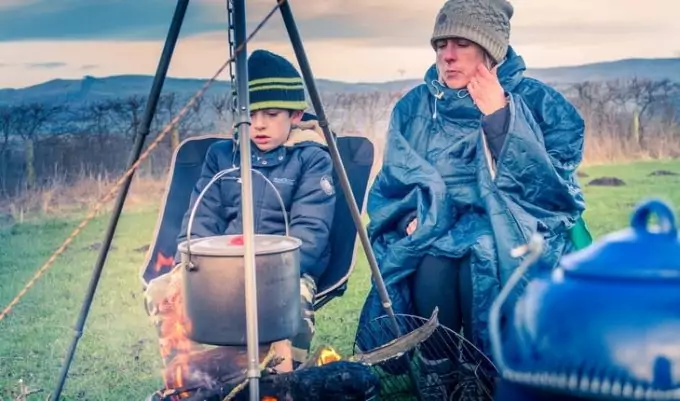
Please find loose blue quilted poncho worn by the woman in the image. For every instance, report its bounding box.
[359,48,585,356]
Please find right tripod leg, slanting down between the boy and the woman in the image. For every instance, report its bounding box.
[279,1,401,336]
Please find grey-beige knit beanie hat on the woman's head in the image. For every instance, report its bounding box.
[430,0,514,63]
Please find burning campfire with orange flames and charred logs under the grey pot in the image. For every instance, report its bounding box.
[146,255,379,401]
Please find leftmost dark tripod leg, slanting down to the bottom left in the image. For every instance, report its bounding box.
[50,0,189,401]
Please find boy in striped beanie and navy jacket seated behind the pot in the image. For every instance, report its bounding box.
[178,50,335,368]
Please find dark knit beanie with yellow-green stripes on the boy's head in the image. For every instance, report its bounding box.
[248,50,307,111]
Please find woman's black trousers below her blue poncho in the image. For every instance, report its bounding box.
[411,255,474,359]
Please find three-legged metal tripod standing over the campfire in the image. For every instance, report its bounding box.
[50,0,401,401]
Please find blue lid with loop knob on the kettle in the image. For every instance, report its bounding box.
[560,199,680,280]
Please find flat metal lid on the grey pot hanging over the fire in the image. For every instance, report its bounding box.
[177,234,302,256]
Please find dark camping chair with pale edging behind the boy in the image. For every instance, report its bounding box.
[136,114,374,310]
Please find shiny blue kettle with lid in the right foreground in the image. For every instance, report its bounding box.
[490,200,680,401]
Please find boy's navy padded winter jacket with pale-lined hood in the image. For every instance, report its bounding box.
[177,120,335,280]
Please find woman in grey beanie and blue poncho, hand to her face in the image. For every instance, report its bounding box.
[359,0,587,372]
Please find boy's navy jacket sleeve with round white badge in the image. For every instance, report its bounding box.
[290,149,336,279]
